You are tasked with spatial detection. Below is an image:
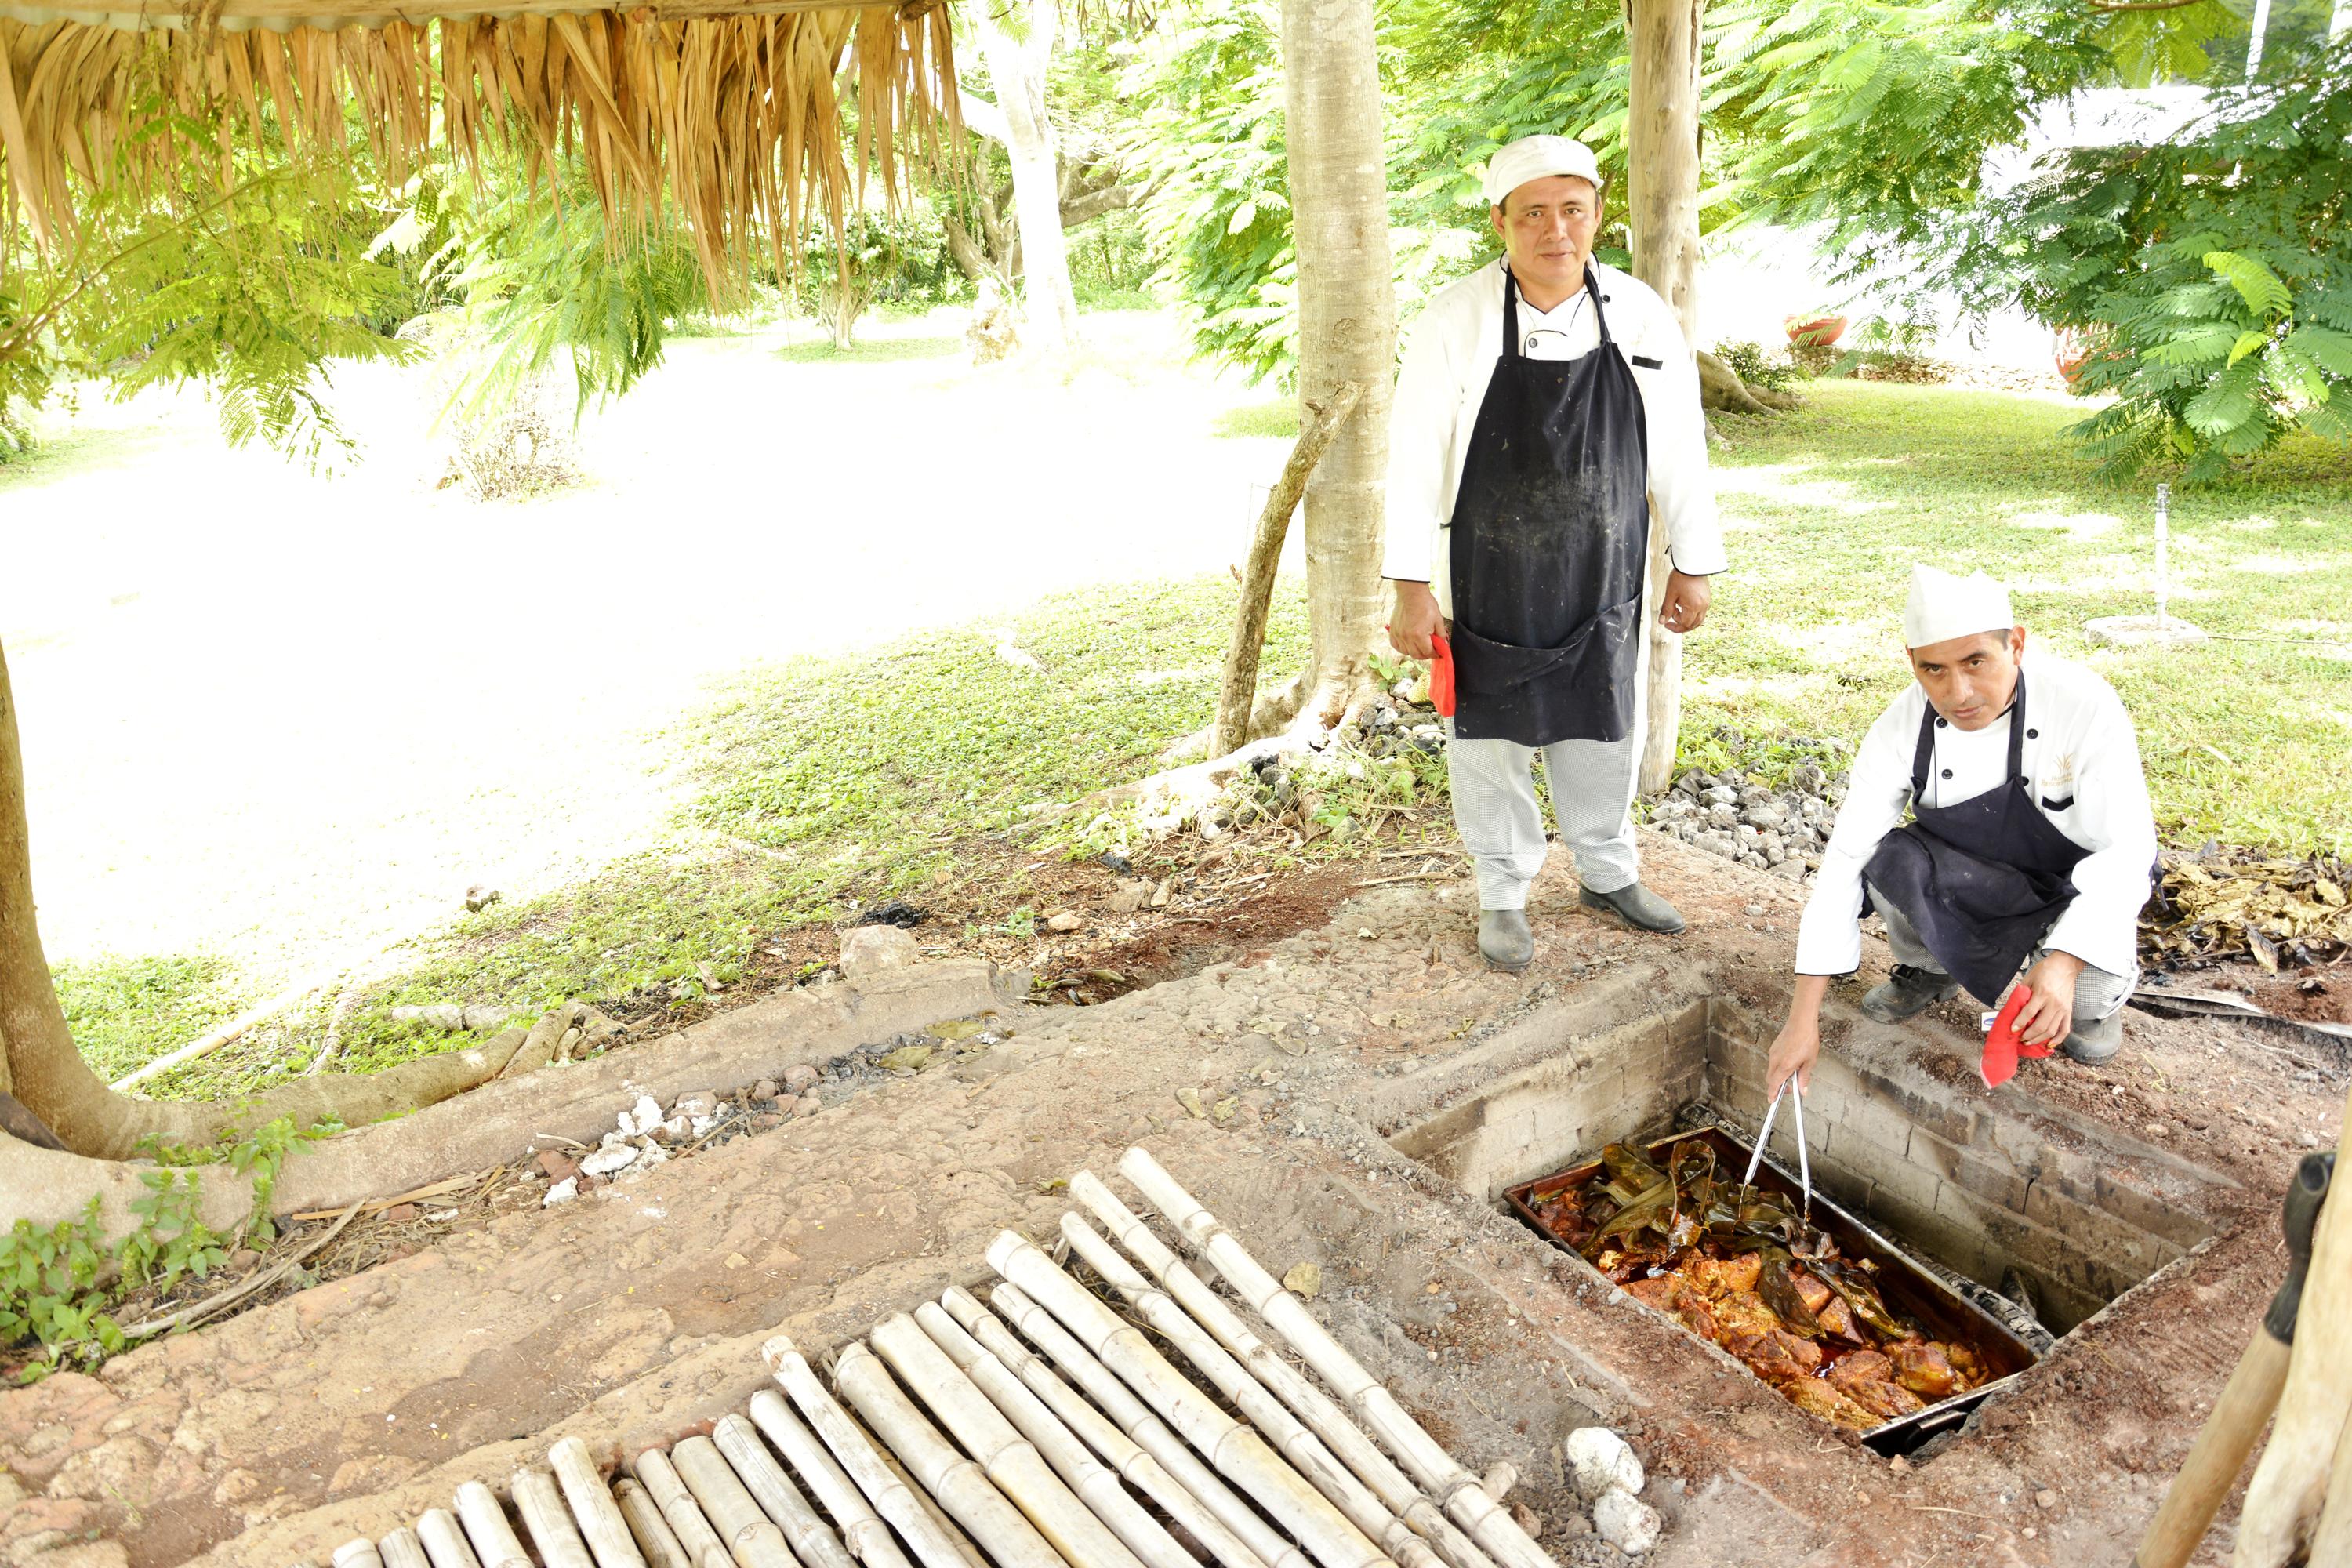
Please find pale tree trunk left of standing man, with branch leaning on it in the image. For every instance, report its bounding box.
[1282,0,1397,727]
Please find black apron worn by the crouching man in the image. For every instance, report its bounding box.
[1863,670,2091,1006]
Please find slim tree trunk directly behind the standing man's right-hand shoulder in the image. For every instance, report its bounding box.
[1625,0,1703,794]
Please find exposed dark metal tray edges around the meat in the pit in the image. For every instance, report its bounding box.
[1503,1116,2051,1453]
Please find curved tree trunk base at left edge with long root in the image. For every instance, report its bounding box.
[0,647,536,1232]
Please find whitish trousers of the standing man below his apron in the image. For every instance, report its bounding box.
[1446,715,1642,909]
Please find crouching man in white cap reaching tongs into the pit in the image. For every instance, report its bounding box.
[1764,567,2157,1093]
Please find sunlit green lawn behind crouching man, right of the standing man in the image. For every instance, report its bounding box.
[1684,381,2352,853]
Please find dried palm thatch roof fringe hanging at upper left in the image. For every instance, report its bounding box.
[0,0,960,278]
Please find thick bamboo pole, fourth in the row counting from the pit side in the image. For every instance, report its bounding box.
[988,1229,1390,1568]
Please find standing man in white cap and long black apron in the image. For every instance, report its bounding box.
[1383,136,1724,971]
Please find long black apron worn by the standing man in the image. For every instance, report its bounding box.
[1449,268,1649,746]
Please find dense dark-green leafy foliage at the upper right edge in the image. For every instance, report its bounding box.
[1959,40,2352,480]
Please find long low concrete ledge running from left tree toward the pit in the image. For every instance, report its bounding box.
[270,959,1025,1213]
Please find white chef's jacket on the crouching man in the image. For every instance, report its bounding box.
[1797,652,2157,975]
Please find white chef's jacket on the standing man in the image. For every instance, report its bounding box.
[1381,261,1724,616]
